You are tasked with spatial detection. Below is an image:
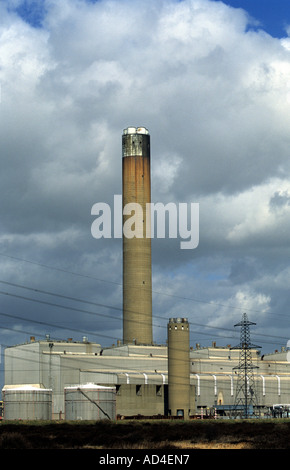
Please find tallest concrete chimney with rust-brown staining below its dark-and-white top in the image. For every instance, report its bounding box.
[122,127,153,344]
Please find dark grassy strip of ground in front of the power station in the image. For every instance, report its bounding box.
[0,419,290,450]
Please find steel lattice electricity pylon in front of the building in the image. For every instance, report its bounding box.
[232,313,260,418]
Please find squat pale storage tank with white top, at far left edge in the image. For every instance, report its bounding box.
[2,385,52,420]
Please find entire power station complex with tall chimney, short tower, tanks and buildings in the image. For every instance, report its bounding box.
[2,127,290,420]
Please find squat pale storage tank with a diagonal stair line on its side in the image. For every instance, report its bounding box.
[64,383,116,420]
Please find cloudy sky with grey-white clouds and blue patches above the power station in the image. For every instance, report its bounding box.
[0,0,290,382]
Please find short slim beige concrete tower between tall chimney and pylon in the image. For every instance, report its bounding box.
[168,318,190,419]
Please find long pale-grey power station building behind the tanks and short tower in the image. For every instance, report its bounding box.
[3,338,290,419]
